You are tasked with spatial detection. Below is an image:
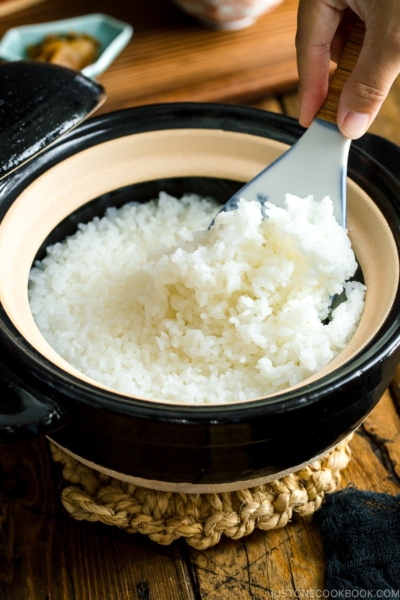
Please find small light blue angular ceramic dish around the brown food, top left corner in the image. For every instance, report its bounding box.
[0,13,133,77]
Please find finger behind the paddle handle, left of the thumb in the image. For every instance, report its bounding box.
[296,0,341,127]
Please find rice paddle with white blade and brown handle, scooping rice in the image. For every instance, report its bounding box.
[222,20,365,227]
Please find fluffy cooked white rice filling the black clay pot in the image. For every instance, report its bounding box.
[29,193,365,404]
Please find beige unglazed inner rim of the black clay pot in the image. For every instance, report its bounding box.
[0,129,399,406]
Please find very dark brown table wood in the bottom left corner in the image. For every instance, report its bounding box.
[0,439,194,600]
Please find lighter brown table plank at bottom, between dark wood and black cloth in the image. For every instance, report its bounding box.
[186,519,325,600]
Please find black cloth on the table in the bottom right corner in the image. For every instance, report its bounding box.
[314,488,400,600]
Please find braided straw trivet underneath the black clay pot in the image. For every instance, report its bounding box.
[51,435,352,550]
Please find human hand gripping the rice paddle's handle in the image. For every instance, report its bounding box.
[296,0,400,139]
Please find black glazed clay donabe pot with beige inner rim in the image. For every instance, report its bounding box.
[0,104,400,492]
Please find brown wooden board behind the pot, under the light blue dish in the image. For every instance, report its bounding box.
[0,0,298,112]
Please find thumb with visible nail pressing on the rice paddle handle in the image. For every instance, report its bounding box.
[337,26,400,139]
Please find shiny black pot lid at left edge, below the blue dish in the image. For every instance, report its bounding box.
[0,61,105,179]
